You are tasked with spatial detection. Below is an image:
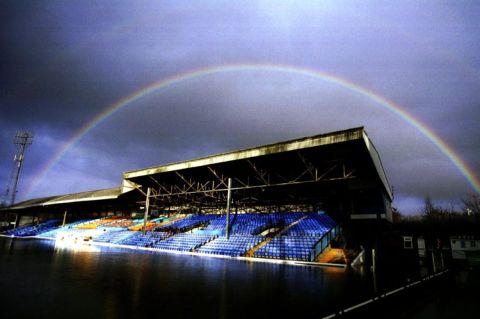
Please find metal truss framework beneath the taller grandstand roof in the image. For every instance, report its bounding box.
[131,152,356,209]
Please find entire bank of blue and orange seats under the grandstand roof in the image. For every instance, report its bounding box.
[0,212,336,261]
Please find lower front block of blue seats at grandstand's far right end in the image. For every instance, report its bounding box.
[254,236,319,261]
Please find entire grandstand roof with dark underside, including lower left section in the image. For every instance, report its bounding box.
[3,127,393,215]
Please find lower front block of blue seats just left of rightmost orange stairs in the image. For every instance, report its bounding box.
[196,235,263,257]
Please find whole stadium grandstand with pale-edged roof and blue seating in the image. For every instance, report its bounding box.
[0,127,393,263]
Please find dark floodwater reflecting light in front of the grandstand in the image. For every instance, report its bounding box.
[0,238,456,318]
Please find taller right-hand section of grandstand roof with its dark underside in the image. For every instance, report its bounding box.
[123,127,393,208]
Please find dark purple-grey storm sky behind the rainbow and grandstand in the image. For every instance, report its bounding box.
[0,0,480,213]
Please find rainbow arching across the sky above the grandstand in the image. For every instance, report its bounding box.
[26,64,480,196]
